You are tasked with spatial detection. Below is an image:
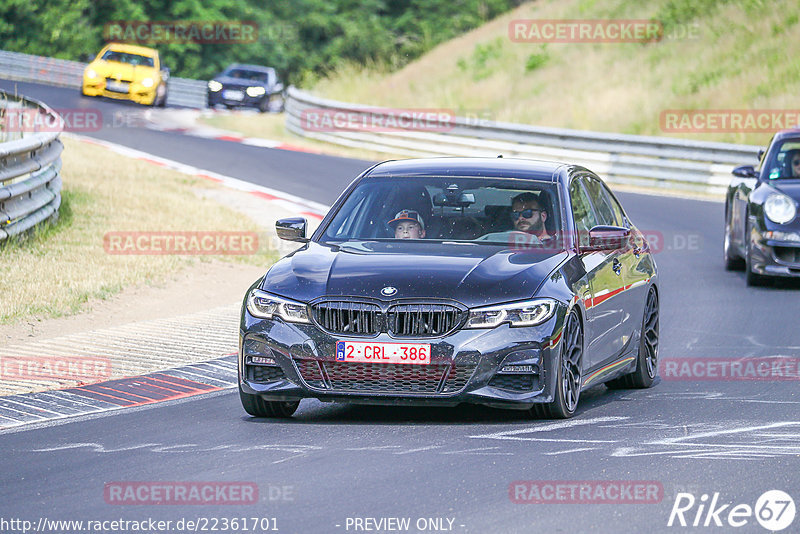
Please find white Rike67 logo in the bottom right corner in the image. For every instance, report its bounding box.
[667,490,797,532]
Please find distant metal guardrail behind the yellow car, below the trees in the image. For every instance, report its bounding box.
[0,50,207,108]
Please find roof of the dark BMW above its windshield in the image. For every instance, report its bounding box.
[365,158,569,182]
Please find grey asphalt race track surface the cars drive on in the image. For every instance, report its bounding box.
[0,81,800,533]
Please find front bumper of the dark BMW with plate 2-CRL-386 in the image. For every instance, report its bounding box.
[239,310,564,409]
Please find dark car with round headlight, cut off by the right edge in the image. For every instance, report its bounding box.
[723,129,800,286]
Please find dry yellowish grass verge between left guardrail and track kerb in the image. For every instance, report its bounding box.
[0,139,276,324]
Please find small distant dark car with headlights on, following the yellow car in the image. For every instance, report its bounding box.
[208,65,283,112]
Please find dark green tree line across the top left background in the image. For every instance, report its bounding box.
[0,0,522,83]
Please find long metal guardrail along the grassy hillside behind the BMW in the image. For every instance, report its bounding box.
[286,87,760,194]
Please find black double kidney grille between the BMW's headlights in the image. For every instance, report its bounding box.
[311,301,463,337]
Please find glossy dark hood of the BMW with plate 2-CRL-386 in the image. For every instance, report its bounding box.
[261,241,567,307]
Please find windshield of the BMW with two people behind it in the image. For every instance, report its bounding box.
[320,176,562,248]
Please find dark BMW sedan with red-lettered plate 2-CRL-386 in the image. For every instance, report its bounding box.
[239,158,659,418]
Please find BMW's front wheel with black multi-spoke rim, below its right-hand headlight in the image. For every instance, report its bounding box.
[531,310,583,419]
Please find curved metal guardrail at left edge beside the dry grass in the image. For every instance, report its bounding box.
[0,91,64,241]
